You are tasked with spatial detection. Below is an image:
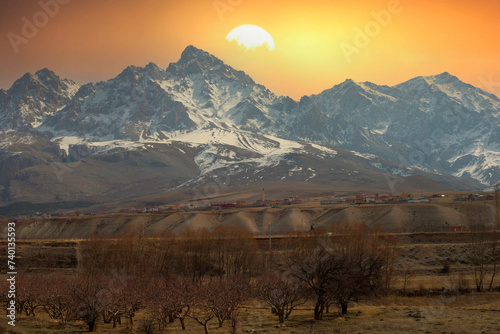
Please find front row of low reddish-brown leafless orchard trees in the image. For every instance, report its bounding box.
[7,272,307,333]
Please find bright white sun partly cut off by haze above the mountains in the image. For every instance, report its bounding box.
[226,24,274,51]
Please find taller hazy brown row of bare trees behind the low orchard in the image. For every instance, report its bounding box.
[78,226,262,281]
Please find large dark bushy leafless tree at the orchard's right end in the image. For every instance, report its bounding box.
[291,224,394,320]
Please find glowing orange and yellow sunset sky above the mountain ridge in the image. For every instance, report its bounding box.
[0,0,500,100]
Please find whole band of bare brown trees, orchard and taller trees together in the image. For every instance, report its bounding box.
[3,224,395,333]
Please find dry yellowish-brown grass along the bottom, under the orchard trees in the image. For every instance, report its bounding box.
[9,293,500,334]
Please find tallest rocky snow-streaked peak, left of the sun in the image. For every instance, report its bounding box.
[40,46,292,141]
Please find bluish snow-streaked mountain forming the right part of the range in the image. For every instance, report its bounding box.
[280,73,500,184]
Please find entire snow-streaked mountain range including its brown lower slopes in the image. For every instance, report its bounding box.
[0,46,500,210]
